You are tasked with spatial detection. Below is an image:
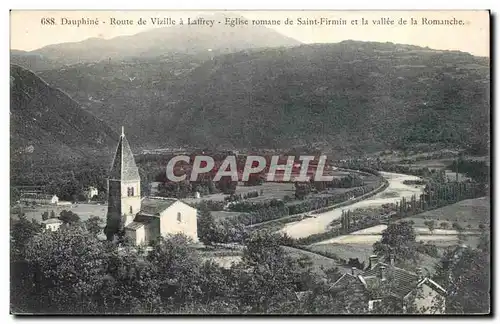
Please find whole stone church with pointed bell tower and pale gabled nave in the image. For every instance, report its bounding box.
[105,128,198,245]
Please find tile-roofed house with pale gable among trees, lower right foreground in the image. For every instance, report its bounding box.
[333,255,446,314]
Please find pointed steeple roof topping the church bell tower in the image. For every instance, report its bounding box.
[109,127,140,181]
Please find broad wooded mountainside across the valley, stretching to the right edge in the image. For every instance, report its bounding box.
[25,41,490,153]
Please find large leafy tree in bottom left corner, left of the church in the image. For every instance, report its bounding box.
[22,227,106,313]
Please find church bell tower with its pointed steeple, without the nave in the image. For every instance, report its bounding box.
[105,127,141,240]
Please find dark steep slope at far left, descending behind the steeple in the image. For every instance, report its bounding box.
[10,65,118,169]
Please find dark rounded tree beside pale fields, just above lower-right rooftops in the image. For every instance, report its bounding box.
[373,221,418,263]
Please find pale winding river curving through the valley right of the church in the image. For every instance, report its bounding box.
[281,172,424,239]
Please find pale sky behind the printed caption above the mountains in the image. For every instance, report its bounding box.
[11,10,490,57]
